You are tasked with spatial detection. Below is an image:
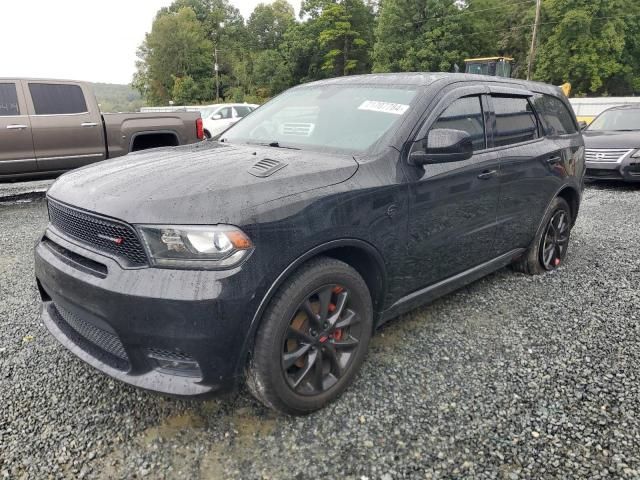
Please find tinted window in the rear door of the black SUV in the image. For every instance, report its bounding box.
[492,95,538,147]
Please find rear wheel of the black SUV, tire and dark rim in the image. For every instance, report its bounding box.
[513,197,573,275]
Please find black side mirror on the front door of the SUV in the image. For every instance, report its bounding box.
[409,128,473,166]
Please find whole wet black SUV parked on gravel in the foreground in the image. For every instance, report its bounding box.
[35,73,585,414]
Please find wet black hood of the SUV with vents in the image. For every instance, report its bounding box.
[47,142,358,225]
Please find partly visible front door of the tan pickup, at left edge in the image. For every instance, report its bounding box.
[0,80,37,175]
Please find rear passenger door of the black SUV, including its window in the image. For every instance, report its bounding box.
[489,87,562,255]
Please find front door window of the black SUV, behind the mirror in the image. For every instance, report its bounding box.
[431,96,487,151]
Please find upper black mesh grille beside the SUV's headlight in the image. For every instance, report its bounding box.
[49,200,147,267]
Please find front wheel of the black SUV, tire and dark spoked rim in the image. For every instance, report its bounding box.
[247,257,373,415]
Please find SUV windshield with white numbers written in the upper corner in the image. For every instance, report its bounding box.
[221,85,416,152]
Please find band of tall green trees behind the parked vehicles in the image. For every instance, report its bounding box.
[133,0,640,105]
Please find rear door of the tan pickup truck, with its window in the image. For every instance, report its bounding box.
[24,80,106,171]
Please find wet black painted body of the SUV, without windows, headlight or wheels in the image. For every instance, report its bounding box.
[35,74,584,396]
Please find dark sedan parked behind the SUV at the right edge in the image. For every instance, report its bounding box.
[582,105,640,182]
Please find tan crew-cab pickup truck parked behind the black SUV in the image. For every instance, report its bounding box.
[0,78,204,178]
